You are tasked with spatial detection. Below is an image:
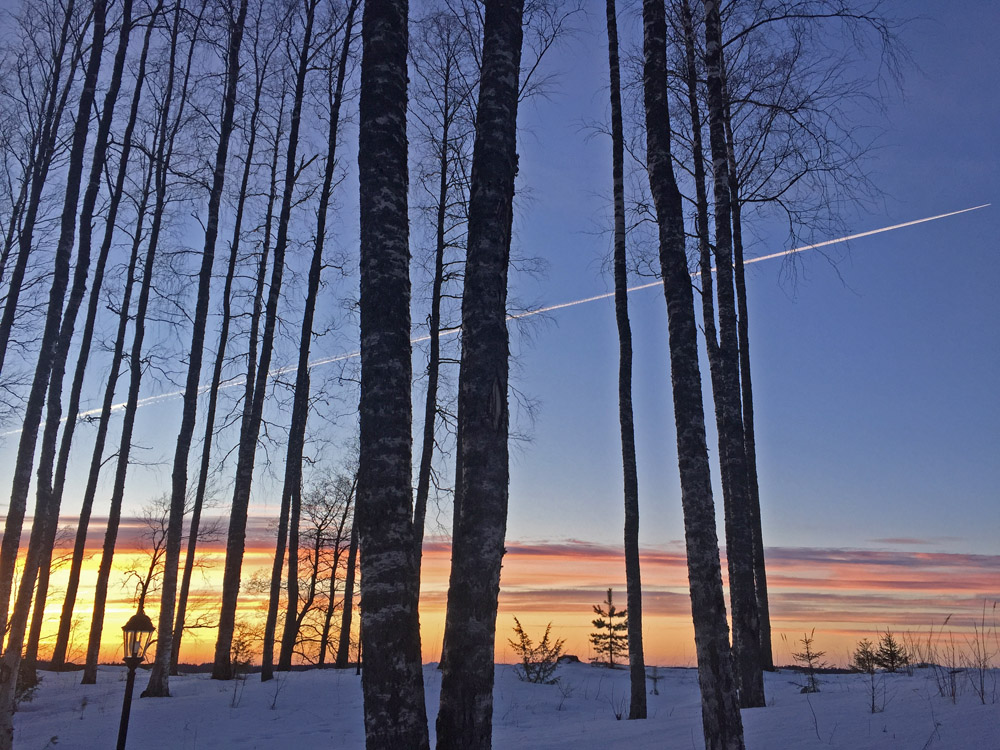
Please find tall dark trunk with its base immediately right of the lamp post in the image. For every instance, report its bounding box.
[142,0,247,697]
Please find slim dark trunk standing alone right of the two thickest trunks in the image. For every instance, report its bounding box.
[607,0,646,719]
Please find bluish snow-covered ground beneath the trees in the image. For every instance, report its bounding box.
[14,664,1000,750]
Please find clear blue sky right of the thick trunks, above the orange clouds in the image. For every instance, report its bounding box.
[509,2,1000,553]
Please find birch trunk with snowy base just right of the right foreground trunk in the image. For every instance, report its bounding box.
[705,0,765,708]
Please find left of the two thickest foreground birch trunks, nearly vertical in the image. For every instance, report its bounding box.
[355,0,429,750]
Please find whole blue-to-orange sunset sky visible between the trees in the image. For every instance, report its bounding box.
[7,0,1000,664]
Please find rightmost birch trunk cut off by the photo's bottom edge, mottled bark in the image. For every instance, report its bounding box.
[642,0,744,750]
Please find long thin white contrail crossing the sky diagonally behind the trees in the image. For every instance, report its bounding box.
[0,203,992,437]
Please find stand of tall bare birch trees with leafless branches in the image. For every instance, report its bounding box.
[0,0,908,750]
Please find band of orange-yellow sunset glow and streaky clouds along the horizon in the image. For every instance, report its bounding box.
[22,519,1000,666]
